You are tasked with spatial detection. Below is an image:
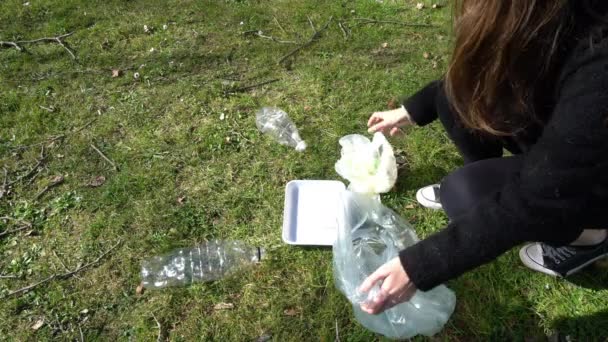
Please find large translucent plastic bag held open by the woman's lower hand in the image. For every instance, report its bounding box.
[333,191,456,339]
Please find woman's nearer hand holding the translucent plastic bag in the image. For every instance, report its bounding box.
[359,258,416,315]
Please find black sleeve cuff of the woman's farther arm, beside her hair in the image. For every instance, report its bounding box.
[401,81,443,126]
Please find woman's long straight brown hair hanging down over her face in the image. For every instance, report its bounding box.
[445,0,568,135]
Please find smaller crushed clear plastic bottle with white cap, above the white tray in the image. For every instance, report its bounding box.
[255,107,306,152]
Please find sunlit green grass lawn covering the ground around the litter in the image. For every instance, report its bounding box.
[0,0,608,341]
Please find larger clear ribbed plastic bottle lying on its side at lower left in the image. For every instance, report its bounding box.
[141,241,264,288]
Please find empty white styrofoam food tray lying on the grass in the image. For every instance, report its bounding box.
[283,180,346,246]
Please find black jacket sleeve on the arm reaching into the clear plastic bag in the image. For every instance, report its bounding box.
[400,41,608,290]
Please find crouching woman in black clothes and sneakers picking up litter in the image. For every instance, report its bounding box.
[360,0,608,313]
